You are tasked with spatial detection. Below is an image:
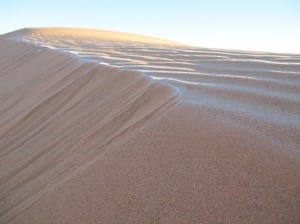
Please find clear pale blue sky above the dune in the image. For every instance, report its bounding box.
[0,0,300,53]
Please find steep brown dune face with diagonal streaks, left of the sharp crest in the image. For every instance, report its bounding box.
[0,37,176,223]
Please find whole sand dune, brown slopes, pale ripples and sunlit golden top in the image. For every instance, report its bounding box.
[0,29,300,224]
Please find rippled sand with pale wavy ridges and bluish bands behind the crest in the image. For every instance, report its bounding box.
[13,28,300,151]
